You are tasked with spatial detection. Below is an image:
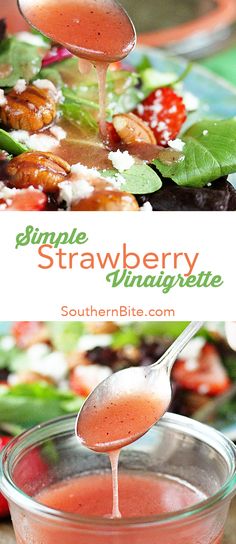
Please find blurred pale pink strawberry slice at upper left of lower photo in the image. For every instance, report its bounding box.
[11,321,48,348]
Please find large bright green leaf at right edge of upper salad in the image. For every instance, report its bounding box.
[153,119,236,187]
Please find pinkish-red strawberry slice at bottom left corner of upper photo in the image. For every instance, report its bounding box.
[6,190,47,212]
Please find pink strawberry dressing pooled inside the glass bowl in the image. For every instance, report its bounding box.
[36,471,206,518]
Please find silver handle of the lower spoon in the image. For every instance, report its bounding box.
[151,321,204,373]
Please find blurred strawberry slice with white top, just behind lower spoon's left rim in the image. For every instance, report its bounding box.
[70,365,112,397]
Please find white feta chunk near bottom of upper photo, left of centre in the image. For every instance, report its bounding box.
[59,179,94,208]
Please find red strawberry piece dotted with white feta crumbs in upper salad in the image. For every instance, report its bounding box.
[134,87,187,147]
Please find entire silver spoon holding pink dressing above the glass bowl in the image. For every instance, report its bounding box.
[76,321,203,453]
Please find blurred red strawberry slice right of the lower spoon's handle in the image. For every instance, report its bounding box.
[172,343,231,395]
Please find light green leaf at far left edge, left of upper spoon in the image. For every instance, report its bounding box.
[0,37,42,88]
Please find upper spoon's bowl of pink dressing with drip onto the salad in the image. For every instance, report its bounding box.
[18,0,136,141]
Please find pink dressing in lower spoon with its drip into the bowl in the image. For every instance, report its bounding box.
[76,393,167,518]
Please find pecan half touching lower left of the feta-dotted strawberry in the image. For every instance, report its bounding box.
[112,113,156,145]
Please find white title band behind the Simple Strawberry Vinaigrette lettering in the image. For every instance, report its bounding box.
[0,212,236,321]
